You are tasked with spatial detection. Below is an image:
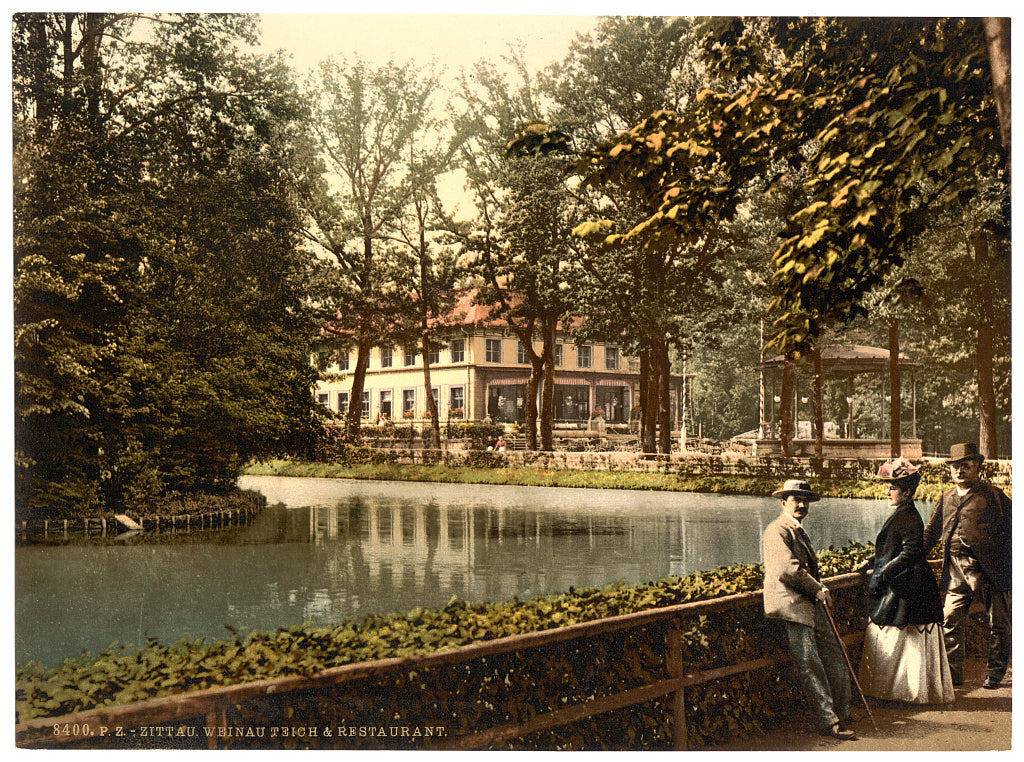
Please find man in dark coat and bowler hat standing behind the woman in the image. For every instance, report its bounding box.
[925,442,1013,689]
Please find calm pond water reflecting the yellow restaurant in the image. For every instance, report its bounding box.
[14,476,901,665]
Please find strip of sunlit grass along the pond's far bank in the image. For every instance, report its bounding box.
[246,460,905,500]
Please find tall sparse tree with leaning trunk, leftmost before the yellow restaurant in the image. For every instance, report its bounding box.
[303,58,437,441]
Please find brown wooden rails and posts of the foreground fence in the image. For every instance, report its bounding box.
[15,574,863,749]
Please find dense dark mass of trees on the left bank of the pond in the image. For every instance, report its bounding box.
[13,13,323,515]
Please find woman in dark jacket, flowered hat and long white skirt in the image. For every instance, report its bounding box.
[859,458,953,704]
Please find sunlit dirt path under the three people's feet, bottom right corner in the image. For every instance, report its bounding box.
[710,661,1013,752]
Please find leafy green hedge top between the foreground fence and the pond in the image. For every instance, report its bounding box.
[16,544,871,721]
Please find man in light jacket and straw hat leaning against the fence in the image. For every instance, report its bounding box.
[761,479,856,740]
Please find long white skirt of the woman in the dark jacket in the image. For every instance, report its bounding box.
[858,622,953,704]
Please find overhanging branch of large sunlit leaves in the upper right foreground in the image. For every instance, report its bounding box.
[536,18,1009,454]
